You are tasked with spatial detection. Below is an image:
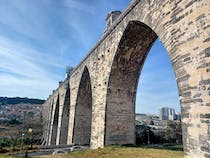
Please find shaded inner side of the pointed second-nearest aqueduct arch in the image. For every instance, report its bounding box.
[73,67,92,145]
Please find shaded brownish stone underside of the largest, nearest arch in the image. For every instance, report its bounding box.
[104,21,180,145]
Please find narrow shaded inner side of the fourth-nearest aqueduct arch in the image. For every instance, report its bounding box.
[51,95,59,145]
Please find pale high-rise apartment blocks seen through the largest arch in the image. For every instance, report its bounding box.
[160,107,181,120]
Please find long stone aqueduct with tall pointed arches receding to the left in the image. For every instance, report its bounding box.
[43,0,210,158]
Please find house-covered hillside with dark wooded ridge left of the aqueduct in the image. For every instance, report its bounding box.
[0,97,45,144]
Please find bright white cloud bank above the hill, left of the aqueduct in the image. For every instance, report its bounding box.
[0,37,63,98]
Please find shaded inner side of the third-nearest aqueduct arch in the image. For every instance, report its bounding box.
[59,86,70,144]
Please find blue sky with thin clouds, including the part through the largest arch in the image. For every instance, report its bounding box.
[0,0,179,113]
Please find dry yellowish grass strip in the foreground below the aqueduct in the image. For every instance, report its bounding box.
[39,147,184,158]
